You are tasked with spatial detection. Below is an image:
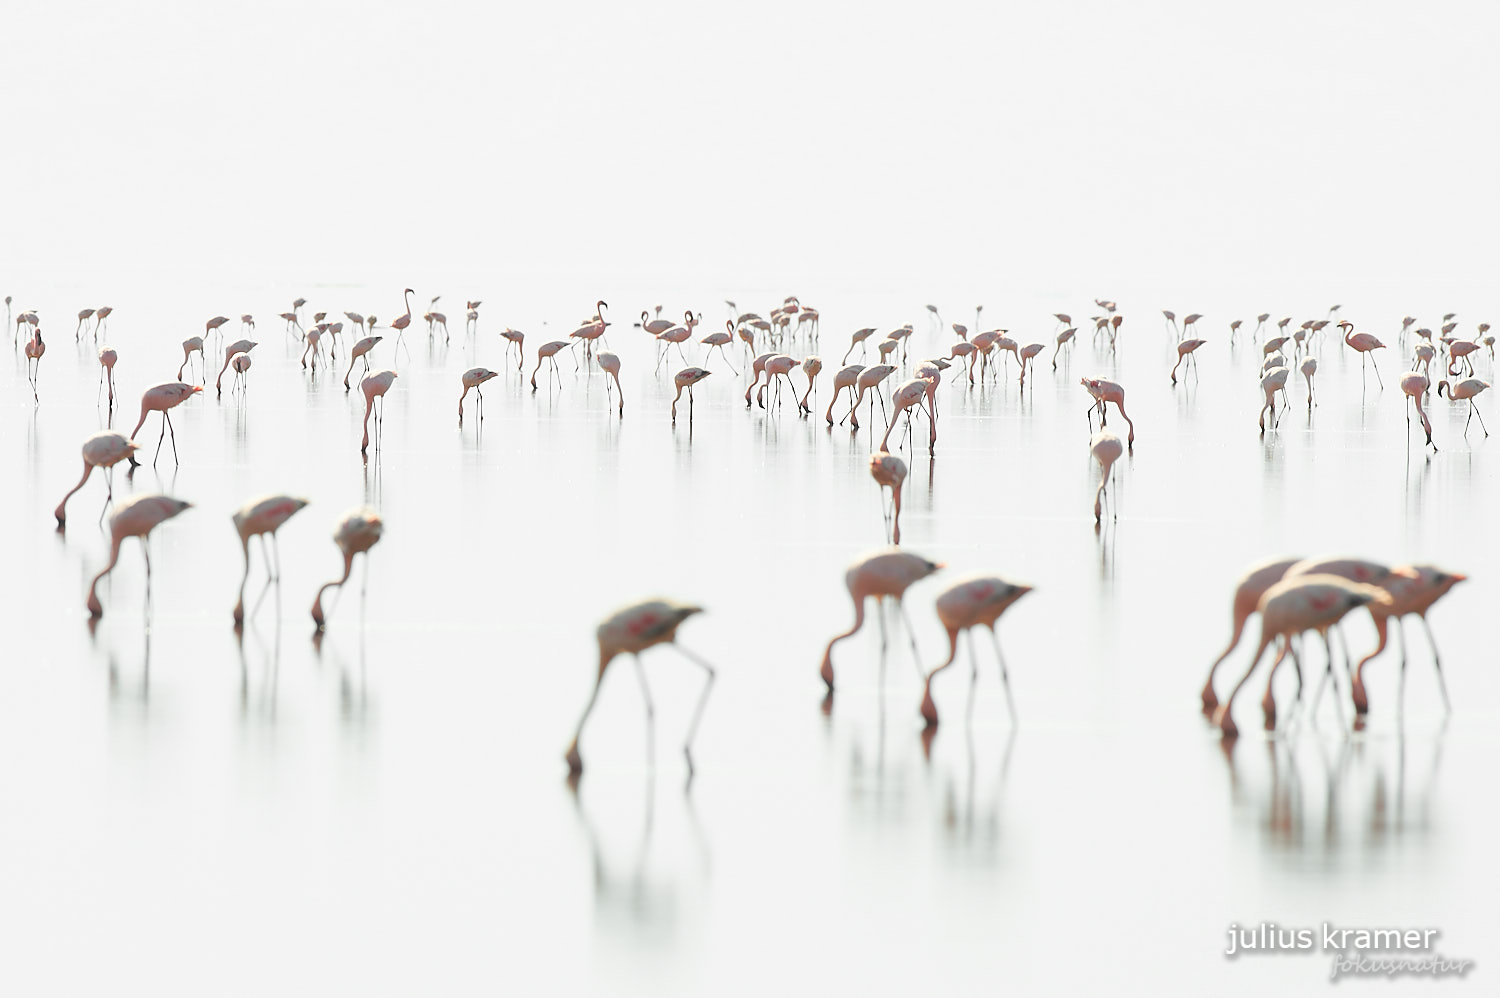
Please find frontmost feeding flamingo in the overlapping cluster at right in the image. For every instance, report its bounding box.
[1214,575,1389,738]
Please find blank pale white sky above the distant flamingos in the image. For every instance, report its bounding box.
[0,0,1500,293]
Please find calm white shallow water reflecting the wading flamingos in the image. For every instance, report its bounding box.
[0,285,1500,995]
